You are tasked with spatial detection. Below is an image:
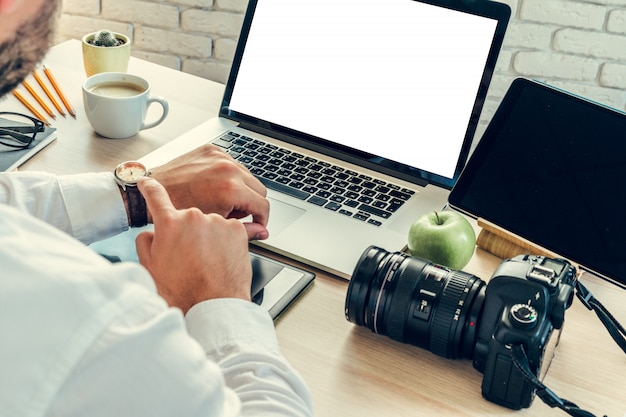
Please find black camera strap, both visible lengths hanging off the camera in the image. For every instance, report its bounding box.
[511,281,626,417]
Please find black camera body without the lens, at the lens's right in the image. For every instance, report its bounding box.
[473,255,576,409]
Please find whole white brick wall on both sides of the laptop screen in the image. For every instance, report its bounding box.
[58,0,626,141]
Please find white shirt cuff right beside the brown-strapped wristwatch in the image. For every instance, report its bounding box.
[57,172,128,243]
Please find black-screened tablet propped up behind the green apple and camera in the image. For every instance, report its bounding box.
[450,78,626,288]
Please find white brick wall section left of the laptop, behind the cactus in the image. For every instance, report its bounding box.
[58,0,248,83]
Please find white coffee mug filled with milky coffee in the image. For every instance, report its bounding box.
[83,72,169,139]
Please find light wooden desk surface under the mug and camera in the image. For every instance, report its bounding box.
[9,41,626,417]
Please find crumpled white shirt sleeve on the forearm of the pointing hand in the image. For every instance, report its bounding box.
[185,299,312,416]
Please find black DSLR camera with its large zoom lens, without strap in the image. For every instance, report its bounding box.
[345,246,577,409]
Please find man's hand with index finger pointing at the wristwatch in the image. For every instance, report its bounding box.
[136,178,252,313]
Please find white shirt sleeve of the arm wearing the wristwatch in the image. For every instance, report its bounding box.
[0,172,128,244]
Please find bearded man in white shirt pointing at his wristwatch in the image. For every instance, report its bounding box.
[0,0,311,416]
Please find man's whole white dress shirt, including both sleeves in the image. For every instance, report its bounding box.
[0,173,312,417]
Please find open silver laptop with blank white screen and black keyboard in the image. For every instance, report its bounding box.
[142,0,510,279]
